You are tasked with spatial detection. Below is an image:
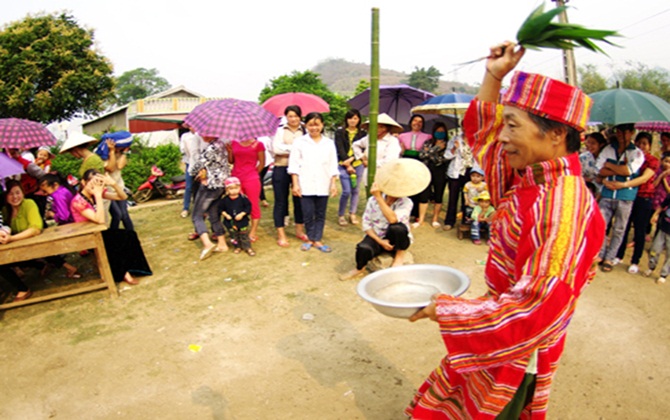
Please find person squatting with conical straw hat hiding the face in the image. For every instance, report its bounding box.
[340,158,430,280]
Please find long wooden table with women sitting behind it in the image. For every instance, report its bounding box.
[0,222,118,310]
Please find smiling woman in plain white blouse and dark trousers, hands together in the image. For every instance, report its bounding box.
[288,112,339,252]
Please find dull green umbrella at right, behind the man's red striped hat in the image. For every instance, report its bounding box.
[589,88,670,125]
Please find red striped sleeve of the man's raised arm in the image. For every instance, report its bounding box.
[463,100,514,208]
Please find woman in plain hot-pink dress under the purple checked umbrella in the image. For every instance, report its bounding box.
[228,139,265,242]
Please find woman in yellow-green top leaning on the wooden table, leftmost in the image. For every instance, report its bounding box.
[0,180,81,302]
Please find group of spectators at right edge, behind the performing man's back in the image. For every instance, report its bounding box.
[579,123,670,283]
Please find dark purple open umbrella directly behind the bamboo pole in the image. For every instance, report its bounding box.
[347,85,435,125]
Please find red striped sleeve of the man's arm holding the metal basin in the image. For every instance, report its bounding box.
[437,177,602,371]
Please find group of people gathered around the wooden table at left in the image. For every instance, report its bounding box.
[0,132,152,302]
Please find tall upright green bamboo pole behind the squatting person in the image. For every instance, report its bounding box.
[366,7,379,196]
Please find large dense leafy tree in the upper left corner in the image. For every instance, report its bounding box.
[0,13,114,123]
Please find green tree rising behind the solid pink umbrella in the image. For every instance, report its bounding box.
[258,70,348,130]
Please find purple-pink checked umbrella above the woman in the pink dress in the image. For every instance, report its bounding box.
[184,98,279,141]
